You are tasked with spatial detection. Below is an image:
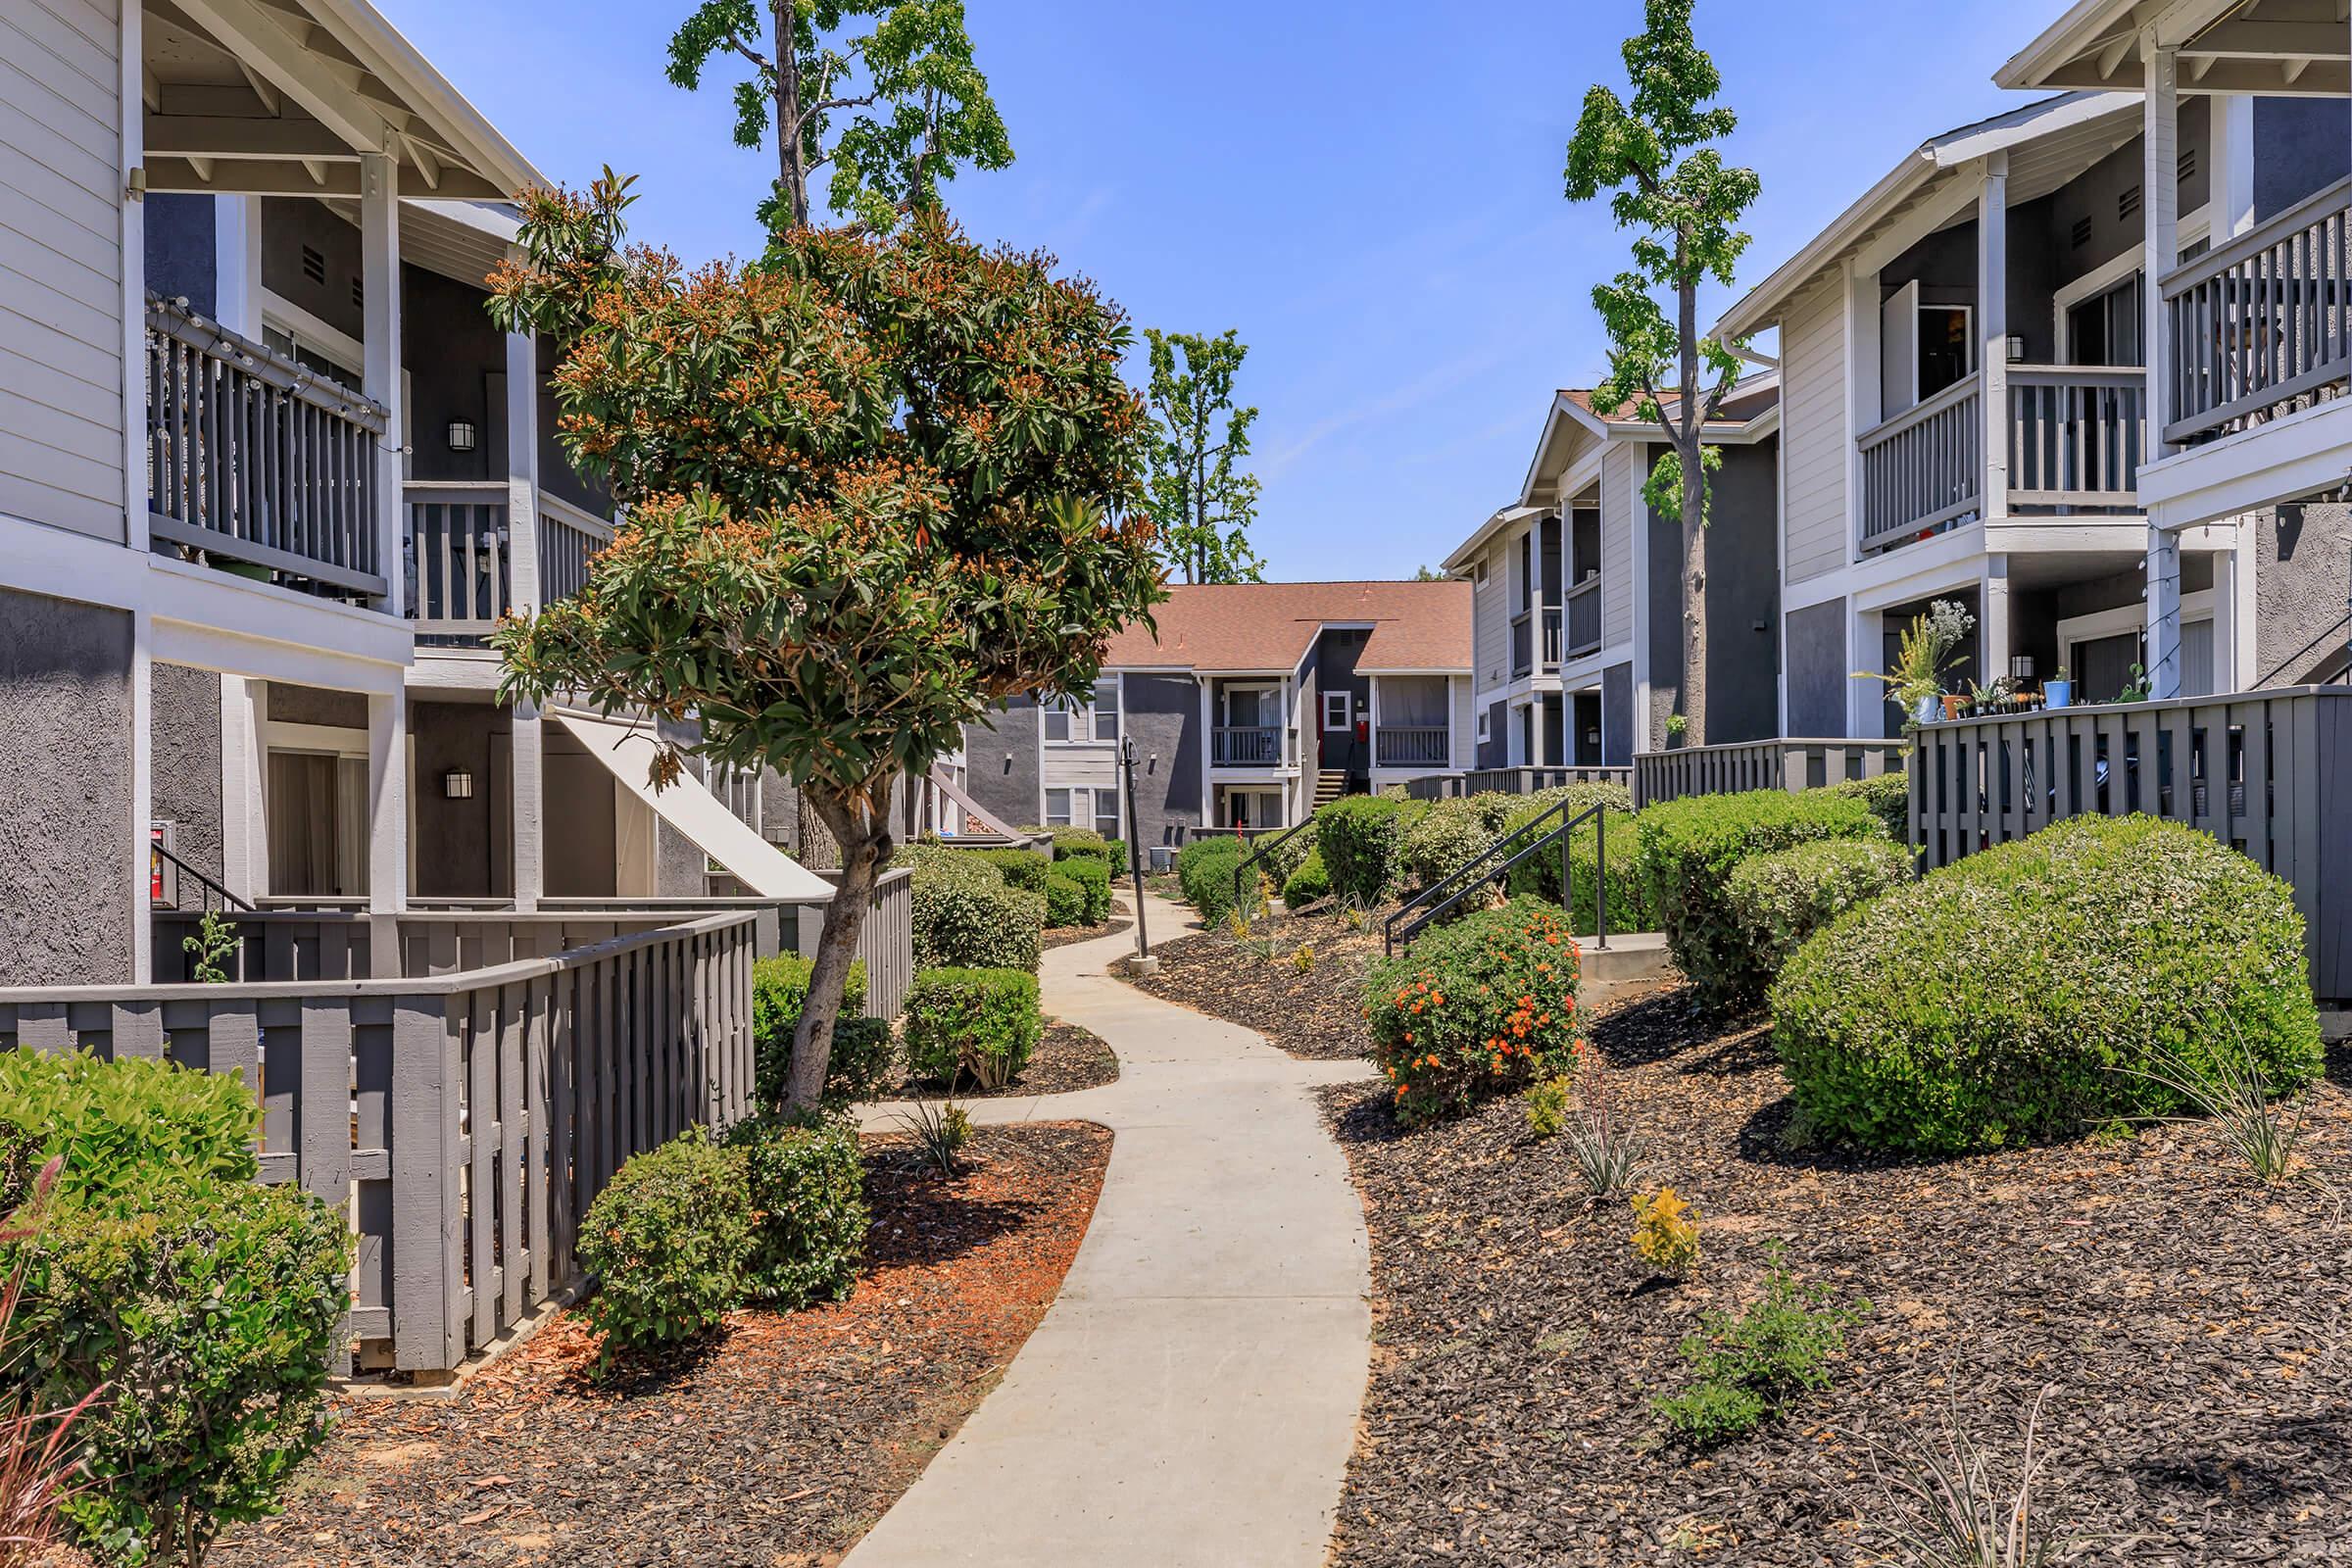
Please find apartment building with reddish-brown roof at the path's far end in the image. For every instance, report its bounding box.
[962,581,1475,844]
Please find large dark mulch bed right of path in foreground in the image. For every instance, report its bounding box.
[1327,990,2352,1568]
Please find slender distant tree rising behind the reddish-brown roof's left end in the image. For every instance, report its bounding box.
[1143,326,1265,583]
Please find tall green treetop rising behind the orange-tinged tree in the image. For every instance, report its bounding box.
[668,0,1013,232]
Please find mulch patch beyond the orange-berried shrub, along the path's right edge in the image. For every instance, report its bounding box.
[1129,906,1381,1060]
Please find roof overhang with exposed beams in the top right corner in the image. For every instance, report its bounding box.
[1992,0,2352,99]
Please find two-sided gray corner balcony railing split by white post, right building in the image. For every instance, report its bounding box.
[1858,365,2147,555]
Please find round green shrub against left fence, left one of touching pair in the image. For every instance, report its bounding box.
[578,1126,751,1363]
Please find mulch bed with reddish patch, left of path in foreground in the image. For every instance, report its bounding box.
[210,1121,1110,1568]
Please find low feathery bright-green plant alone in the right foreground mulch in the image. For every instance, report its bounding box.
[1653,1249,1870,1446]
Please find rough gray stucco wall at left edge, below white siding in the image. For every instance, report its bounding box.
[0,588,146,985]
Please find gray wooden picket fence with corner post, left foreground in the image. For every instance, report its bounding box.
[0,912,758,1373]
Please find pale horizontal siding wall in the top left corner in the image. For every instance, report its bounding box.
[0,0,124,538]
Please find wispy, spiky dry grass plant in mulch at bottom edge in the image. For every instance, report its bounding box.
[1865,1387,2095,1568]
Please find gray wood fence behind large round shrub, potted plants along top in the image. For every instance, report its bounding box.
[1910,686,2352,1002]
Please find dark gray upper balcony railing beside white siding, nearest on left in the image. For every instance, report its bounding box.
[146,294,386,597]
